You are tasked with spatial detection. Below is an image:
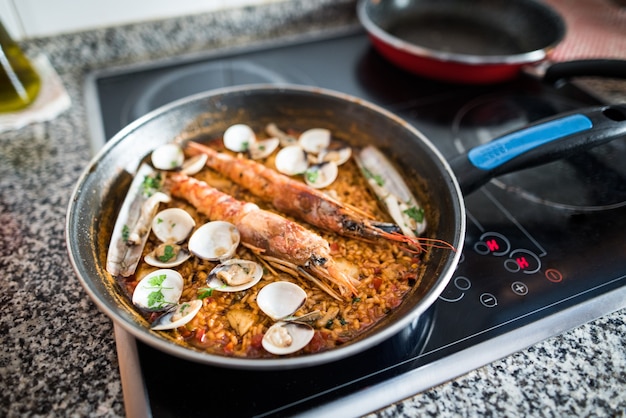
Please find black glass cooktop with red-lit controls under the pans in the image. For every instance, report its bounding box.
[87,30,626,417]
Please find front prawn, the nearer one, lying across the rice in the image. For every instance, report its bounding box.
[167,174,360,299]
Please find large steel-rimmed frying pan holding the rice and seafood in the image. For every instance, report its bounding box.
[66,85,626,369]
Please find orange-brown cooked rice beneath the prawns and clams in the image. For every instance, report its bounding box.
[119,138,419,358]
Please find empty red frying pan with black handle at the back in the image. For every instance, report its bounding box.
[357,0,626,84]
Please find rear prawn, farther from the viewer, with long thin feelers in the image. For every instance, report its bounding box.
[187,141,452,253]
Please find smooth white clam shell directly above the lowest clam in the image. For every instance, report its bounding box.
[256,281,307,321]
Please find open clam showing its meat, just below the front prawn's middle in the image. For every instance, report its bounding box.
[207,258,263,292]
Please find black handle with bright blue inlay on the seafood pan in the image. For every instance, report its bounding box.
[450,104,626,195]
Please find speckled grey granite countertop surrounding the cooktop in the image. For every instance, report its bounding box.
[0,0,626,417]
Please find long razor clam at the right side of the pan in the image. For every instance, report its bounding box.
[355,146,426,237]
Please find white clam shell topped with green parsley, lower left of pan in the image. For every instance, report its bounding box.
[133,269,184,311]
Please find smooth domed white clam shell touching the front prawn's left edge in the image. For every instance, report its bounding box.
[188,221,241,261]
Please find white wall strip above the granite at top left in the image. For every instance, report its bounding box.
[0,0,285,39]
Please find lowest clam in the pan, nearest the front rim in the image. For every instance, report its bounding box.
[261,322,315,355]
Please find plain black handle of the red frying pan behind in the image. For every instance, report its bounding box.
[542,59,626,84]
